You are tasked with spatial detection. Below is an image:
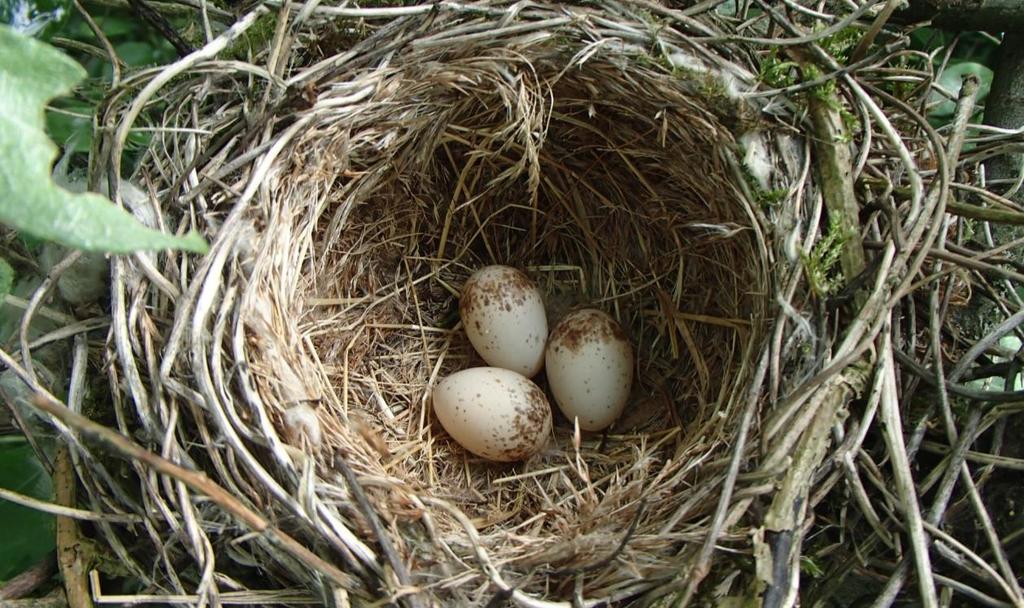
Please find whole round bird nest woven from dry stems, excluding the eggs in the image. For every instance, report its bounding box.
[24,2,1015,606]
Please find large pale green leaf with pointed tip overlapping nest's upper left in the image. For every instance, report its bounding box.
[0,26,209,253]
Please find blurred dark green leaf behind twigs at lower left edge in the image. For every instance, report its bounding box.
[0,440,56,580]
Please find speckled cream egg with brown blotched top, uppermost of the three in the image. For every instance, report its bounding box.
[459,266,548,378]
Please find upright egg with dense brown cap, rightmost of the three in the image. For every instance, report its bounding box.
[545,308,633,431]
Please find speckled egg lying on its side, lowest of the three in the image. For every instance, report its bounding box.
[432,367,551,463]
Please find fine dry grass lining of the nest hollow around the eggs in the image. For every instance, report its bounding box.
[232,33,769,597]
